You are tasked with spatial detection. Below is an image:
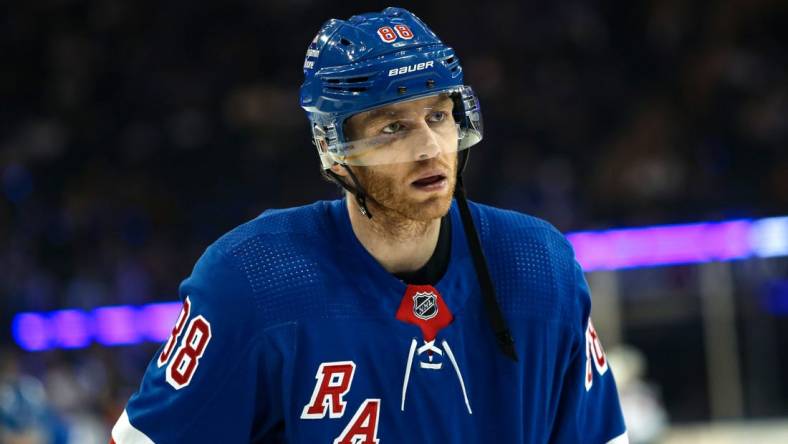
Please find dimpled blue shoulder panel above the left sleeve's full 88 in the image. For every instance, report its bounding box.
[192,201,336,326]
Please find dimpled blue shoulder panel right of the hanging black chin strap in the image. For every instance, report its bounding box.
[473,204,580,322]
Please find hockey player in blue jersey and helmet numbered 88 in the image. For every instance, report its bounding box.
[112,8,627,444]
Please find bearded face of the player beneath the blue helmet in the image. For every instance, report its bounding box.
[334,95,457,221]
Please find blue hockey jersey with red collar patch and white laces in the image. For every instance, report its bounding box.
[112,200,627,444]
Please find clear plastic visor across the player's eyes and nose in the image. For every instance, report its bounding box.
[323,91,482,166]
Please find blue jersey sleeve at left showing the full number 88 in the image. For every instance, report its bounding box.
[110,246,281,444]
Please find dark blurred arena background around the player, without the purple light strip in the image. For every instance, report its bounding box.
[0,0,788,444]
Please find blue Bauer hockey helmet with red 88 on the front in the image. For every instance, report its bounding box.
[301,7,483,170]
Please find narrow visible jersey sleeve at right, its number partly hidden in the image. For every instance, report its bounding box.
[550,261,629,444]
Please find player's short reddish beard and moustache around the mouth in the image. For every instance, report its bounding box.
[353,153,457,228]
